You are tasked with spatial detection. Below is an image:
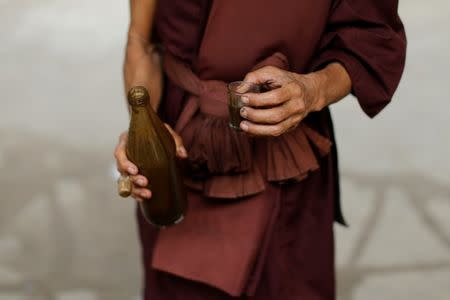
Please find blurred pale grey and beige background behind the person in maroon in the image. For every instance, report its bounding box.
[0,0,450,300]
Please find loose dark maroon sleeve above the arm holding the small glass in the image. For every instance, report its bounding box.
[312,0,406,117]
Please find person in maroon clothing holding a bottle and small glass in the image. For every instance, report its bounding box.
[115,0,406,300]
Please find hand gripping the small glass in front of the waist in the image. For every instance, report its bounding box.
[240,66,322,136]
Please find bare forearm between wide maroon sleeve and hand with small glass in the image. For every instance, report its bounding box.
[305,62,352,111]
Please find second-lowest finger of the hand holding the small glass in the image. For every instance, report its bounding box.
[240,101,296,124]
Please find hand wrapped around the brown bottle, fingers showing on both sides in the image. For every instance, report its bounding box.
[114,124,187,201]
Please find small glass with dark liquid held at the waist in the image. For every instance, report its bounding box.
[228,81,260,131]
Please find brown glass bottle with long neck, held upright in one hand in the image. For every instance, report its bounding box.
[127,86,187,227]
